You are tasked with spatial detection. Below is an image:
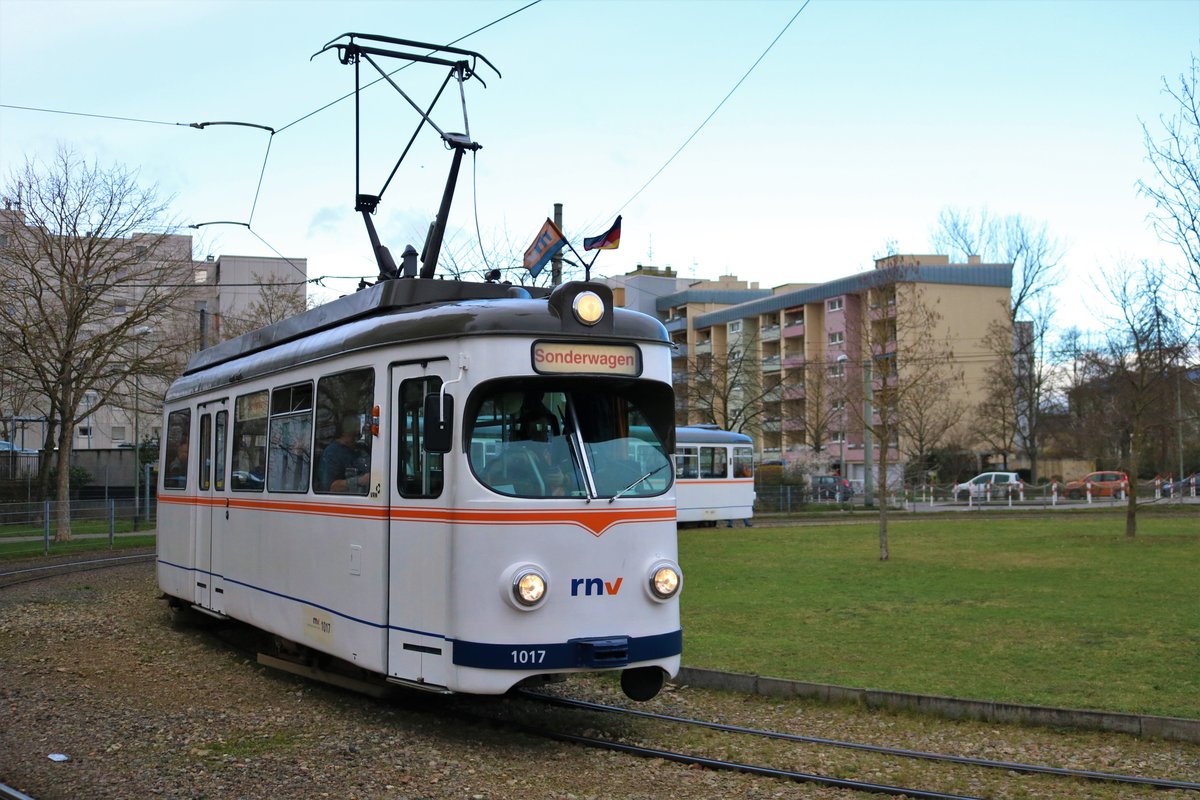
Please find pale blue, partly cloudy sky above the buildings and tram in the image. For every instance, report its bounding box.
[0,0,1200,330]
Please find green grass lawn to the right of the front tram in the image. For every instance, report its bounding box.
[679,512,1200,718]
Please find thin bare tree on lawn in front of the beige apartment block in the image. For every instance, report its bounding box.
[842,255,961,561]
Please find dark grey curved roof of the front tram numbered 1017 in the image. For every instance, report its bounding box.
[169,278,670,396]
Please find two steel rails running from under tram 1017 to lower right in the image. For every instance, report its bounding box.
[521,690,1200,798]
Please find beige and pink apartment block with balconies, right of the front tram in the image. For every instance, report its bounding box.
[604,255,1012,481]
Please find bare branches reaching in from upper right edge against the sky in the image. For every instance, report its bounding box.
[1138,55,1200,302]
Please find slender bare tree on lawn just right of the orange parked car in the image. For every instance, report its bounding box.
[1090,261,1188,537]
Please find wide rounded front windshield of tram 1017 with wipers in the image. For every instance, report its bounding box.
[467,378,674,500]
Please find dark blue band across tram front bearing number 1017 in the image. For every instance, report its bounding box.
[451,628,683,670]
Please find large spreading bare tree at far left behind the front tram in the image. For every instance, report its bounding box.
[0,148,192,541]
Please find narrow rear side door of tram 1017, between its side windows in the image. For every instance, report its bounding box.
[192,399,229,612]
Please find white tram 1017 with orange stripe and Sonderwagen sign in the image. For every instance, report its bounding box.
[157,278,683,699]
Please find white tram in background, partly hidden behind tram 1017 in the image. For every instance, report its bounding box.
[674,426,755,525]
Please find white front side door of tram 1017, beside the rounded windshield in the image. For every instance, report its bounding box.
[388,359,451,686]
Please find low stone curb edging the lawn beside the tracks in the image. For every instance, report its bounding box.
[674,667,1200,744]
